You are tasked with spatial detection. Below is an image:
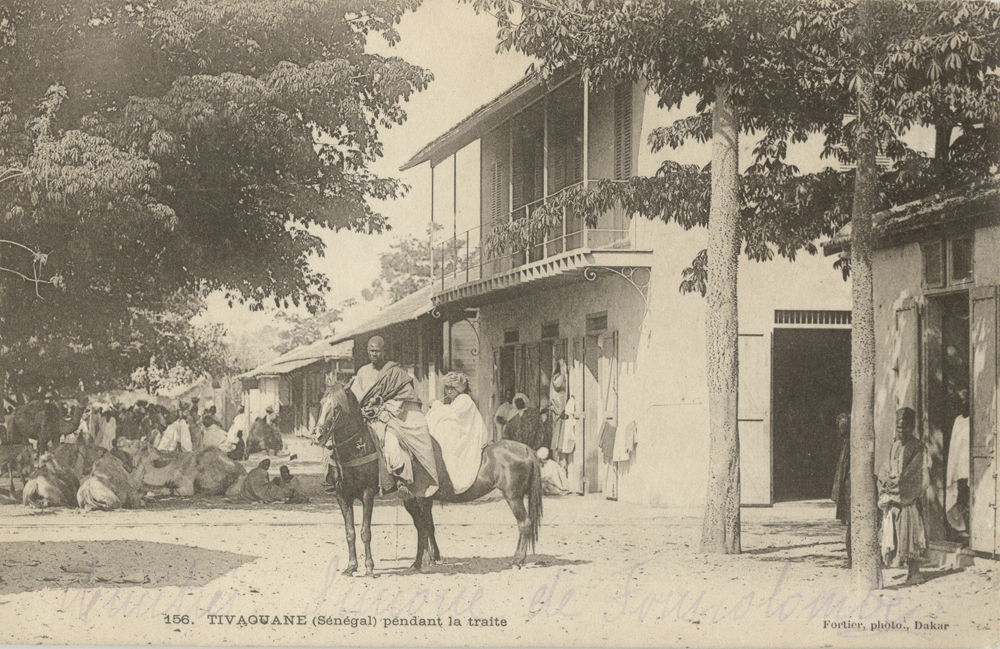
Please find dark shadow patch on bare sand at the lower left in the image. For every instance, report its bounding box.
[0,540,257,595]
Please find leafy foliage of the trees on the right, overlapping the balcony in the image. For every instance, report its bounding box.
[476,0,1000,290]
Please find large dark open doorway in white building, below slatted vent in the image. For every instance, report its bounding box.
[771,328,851,502]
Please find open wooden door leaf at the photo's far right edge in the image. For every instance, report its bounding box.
[969,286,1000,554]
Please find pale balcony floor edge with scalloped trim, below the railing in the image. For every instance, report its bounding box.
[434,248,653,310]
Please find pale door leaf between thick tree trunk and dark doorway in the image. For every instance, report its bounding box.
[737,334,773,505]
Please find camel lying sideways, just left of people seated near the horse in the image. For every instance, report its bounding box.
[132,446,246,496]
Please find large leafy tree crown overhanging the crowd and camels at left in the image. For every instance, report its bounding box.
[0,0,430,392]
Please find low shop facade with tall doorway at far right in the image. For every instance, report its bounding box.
[826,188,1000,555]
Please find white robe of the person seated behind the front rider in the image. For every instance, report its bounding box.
[427,394,489,494]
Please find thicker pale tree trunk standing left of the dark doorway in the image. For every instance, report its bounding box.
[701,86,740,554]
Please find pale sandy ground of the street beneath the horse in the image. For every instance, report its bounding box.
[0,438,1000,647]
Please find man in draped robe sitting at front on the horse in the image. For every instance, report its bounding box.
[350,336,438,498]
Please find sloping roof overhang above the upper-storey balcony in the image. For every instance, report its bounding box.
[399,71,576,171]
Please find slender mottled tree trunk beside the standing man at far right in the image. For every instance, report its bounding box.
[851,0,882,591]
